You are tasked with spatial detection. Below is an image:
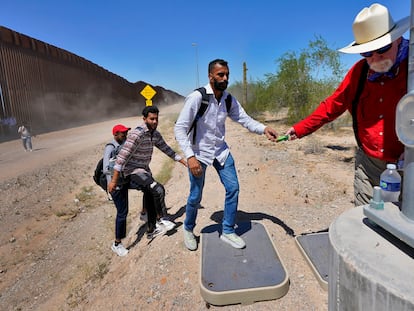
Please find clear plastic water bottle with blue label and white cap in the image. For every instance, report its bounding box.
[380,164,401,202]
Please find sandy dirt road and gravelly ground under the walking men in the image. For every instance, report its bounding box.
[0,106,355,310]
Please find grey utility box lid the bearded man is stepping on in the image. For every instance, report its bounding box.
[200,222,289,305]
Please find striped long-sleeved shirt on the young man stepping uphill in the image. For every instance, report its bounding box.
[114,124,181,176]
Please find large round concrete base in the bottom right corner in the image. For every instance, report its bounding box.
[328,206,414,311]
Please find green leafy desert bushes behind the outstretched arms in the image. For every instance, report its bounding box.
[229,36,350,126]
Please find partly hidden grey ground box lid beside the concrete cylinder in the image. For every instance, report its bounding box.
[295,232,330,291]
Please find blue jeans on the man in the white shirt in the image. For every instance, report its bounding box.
[184,154,240,233]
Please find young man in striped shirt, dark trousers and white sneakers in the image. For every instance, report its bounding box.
[108,106,187,256]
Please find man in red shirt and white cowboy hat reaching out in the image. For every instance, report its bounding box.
[286,3,410,206]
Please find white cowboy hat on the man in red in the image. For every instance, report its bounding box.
[339,3,410,54]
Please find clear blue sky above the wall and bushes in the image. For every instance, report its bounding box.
[0,0,411,95]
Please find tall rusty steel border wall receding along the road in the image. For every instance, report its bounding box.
[0,26,145,141]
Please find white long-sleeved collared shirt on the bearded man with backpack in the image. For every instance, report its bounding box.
[174,84,266,165]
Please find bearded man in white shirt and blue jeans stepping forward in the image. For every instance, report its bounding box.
[175,59,277,251]
